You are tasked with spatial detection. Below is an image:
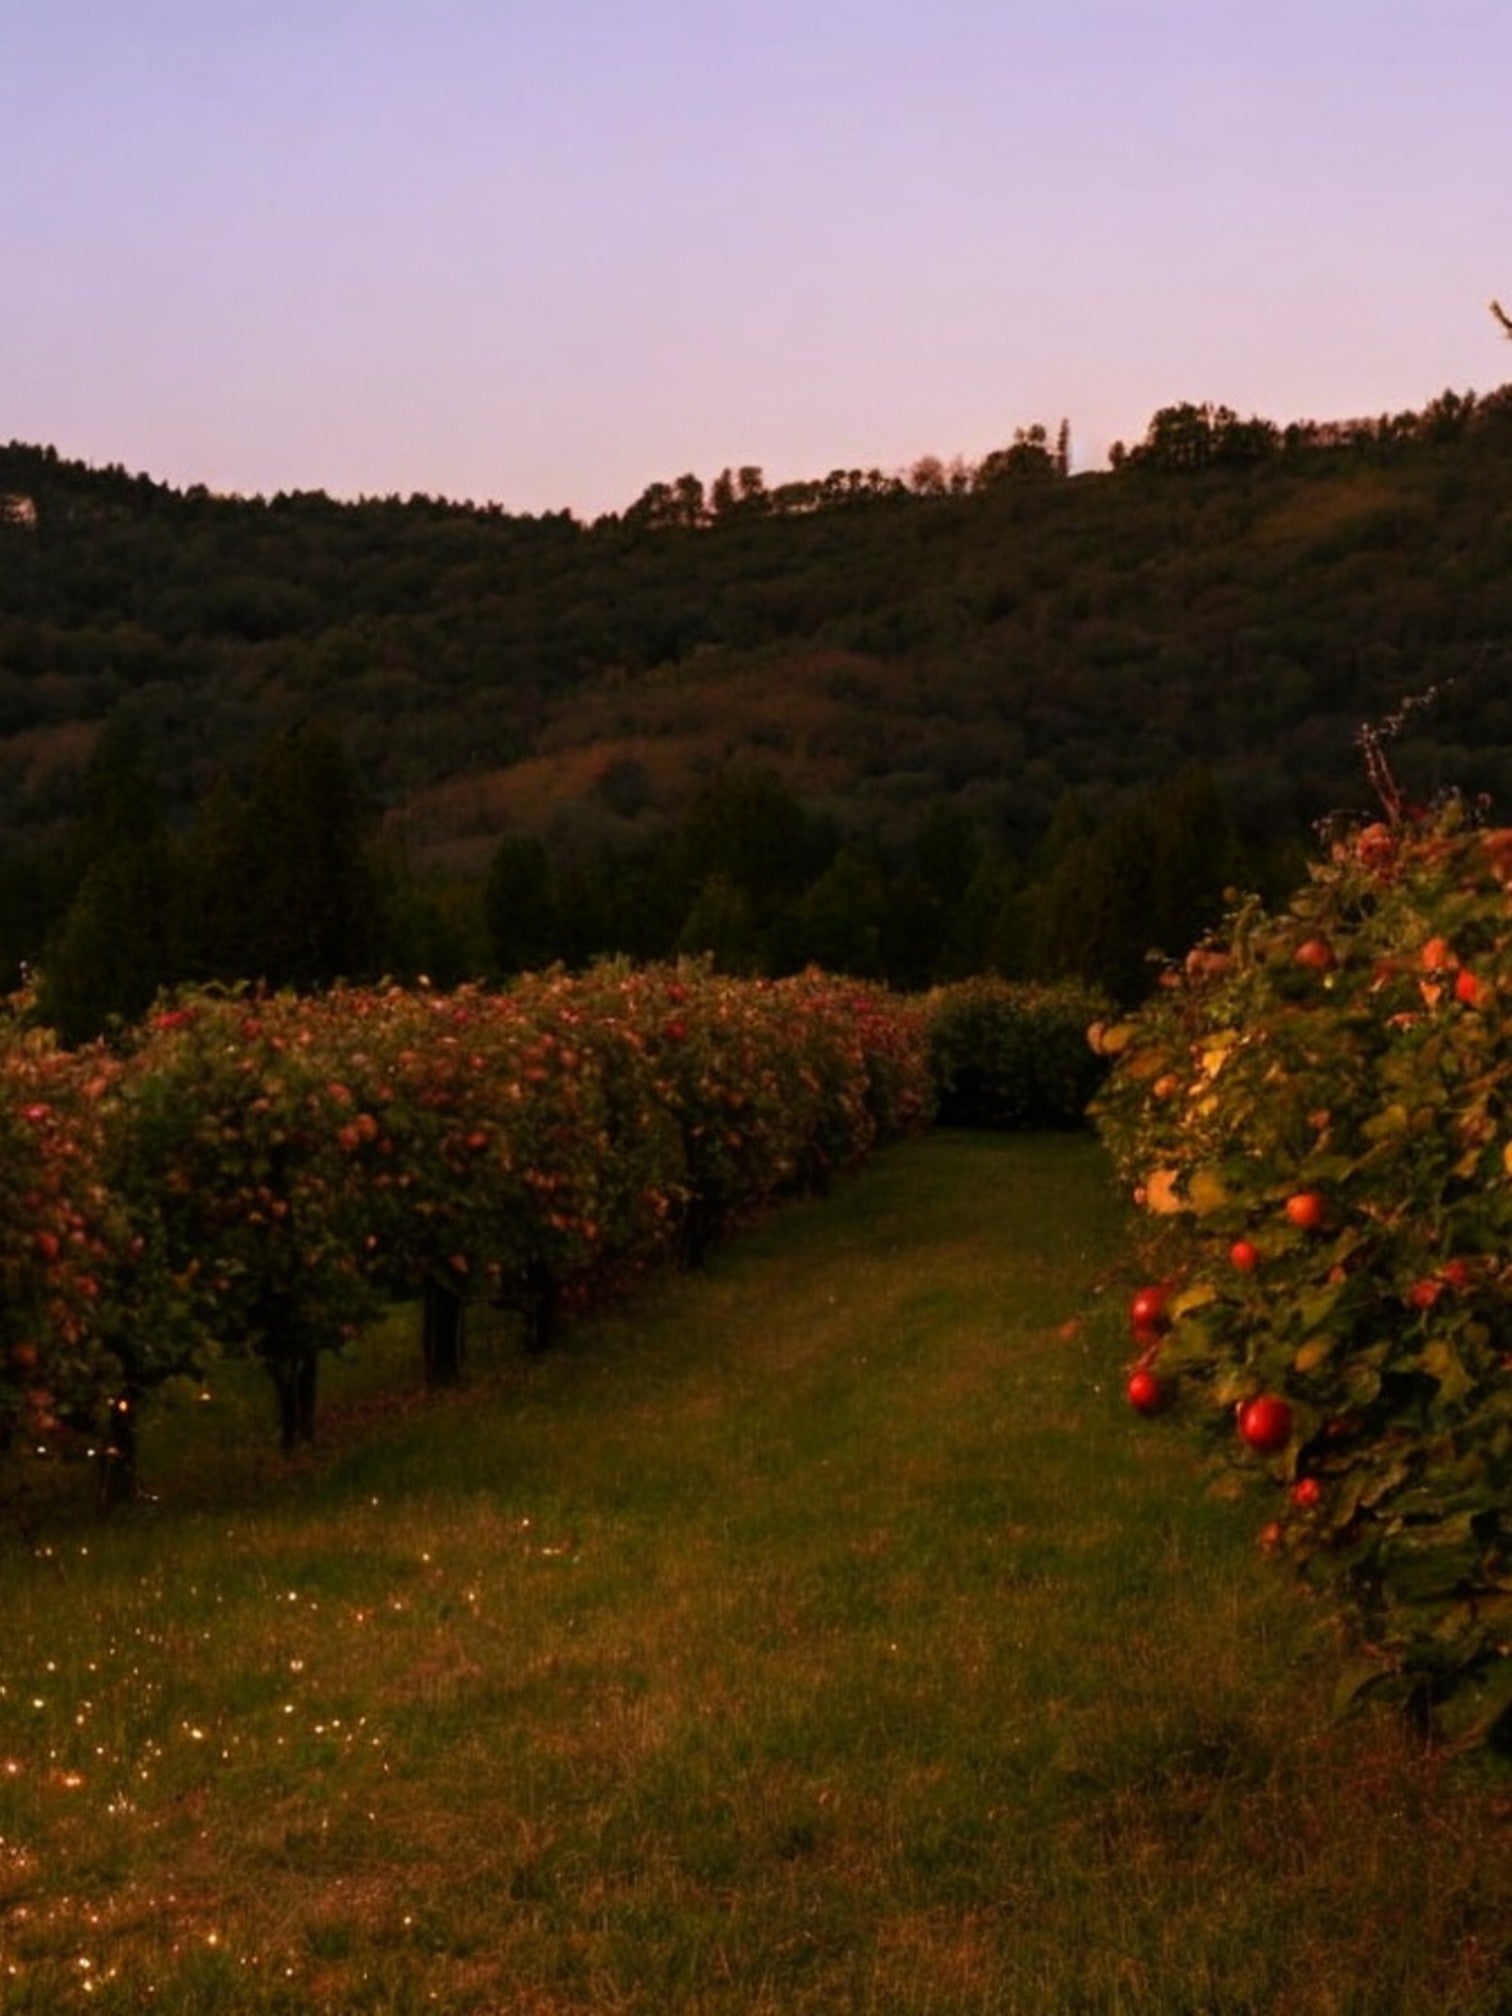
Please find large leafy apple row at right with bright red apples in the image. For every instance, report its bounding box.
[1095,804,1512,1742]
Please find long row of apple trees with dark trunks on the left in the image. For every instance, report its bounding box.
[0,966,931,1494]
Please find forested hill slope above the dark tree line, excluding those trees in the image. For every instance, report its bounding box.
[0,387,1512,1032]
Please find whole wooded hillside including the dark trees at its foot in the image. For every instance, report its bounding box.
[0,387,1512,1038]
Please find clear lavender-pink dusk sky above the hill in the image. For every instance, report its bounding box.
[0,0,1512,518]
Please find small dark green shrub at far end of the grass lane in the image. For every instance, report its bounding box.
[925,978,1109,1129]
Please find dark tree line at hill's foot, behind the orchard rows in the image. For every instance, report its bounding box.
[23,701,1288,1042]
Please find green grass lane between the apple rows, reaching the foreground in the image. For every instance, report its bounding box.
[0,1135,1512,2016]
